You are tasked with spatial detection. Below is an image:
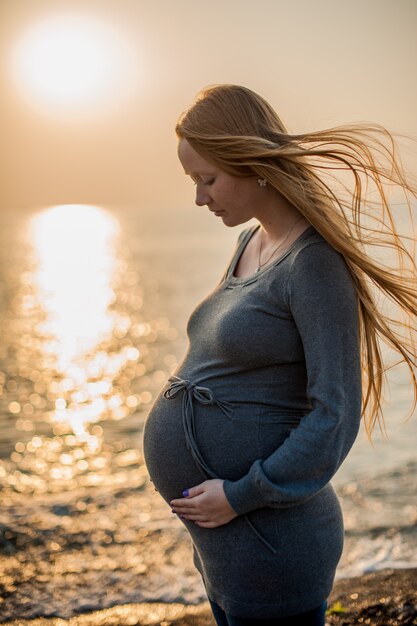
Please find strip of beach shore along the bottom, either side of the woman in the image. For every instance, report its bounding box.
[3,568,417,626]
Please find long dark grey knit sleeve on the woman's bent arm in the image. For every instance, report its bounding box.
[224,242,361,514]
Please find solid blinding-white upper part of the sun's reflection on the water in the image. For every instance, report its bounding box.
[31,205,118,364]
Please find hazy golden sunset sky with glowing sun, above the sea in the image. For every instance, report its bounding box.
[0,0,417,210]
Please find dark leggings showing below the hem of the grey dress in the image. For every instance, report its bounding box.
[210,600,327,626]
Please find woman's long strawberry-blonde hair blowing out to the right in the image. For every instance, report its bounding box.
[176,85,417,436]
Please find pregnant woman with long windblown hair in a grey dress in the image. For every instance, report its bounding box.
[144,85,417,626]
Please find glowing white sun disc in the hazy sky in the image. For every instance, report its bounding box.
[11,15,137,111]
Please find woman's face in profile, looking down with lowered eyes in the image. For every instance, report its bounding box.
[178,139,265,226]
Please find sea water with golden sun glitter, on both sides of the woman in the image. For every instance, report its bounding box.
[0,206,417,621]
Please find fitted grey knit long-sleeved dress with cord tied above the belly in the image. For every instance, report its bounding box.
[144,226,361,619]
